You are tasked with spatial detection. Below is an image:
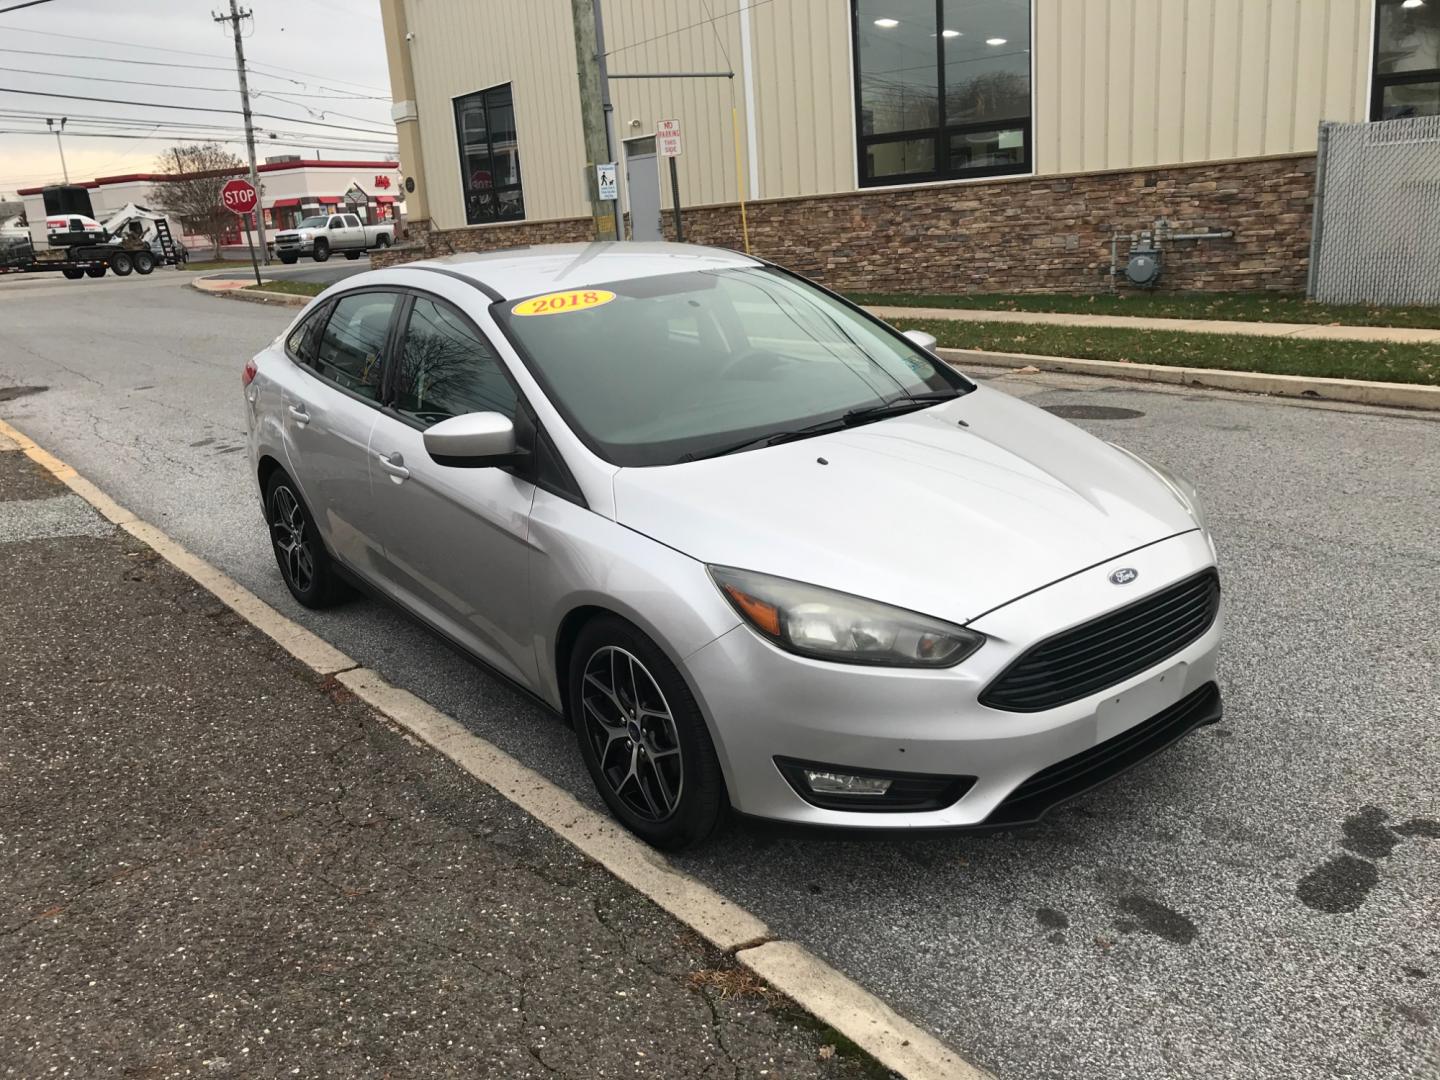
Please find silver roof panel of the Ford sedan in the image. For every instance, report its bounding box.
[396,240,763,300]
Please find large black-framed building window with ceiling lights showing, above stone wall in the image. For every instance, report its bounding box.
[851,0,1031,186]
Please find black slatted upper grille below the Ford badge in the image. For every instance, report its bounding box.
[979,570,1220,713]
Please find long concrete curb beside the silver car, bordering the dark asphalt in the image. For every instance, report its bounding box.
[0,411,988,1080]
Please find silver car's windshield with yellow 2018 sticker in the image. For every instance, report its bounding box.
[492,266,973,465]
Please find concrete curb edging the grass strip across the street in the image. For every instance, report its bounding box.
[936,348,1440,410]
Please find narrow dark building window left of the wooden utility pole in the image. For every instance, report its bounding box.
[455,85,526,225]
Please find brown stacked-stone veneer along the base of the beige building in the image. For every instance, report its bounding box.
[372,154,1315,292]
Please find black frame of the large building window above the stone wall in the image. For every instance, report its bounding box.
[850,0,1035,187]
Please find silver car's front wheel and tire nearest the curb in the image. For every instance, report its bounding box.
[567,615,727,851]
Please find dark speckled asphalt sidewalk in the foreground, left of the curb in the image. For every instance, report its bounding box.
[0,439,877,1080]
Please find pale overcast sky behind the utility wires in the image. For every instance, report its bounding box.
[0,0,395,197]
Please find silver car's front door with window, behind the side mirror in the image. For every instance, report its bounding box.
[370,295,536,685]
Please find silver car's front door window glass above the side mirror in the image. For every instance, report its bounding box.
[395,297,517,428]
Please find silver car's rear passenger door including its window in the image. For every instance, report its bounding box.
[284,289,402,576]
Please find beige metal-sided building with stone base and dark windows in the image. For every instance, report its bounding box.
[382,0,1440,289]
